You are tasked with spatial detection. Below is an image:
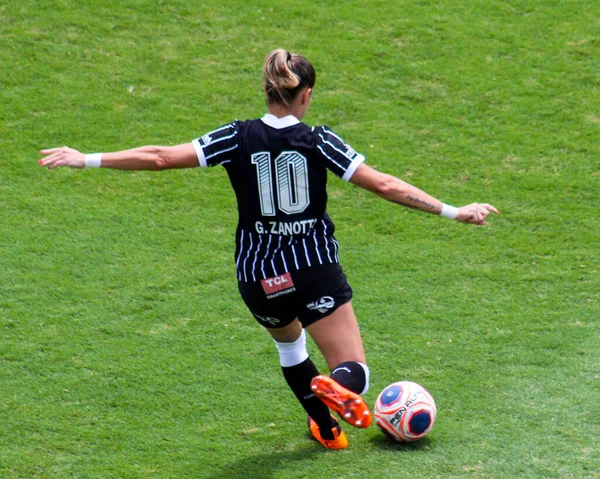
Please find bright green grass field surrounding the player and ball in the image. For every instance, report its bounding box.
[0,0,600,479]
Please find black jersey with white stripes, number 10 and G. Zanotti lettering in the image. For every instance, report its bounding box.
[192,114,365,282]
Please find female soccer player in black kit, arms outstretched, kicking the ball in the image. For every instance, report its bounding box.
[39,49,498,449]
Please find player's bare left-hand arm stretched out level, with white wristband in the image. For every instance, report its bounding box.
[39,143,200,171]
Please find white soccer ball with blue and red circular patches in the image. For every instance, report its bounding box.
[374,381,437,442]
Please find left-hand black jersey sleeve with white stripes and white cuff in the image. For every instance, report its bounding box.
[192,121,240,168]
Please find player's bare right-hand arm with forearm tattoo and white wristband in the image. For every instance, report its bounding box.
[350,163,498,225]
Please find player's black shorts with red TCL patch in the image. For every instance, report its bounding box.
[238,264,352,328]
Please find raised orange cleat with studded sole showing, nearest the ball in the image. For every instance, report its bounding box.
[310,375,373,428]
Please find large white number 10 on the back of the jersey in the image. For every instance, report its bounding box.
[252,151,310,216]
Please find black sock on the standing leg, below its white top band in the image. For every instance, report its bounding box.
[281,358,334,439]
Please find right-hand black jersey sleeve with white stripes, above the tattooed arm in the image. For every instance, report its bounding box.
[313,126,365,181]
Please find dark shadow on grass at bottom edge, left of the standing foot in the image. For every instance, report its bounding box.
[208,444,323,479]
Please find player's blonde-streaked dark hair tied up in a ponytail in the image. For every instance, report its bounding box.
[263,48,316,106]
